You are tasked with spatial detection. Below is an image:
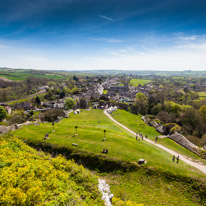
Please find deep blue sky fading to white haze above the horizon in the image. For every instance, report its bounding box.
[0,0,206,70]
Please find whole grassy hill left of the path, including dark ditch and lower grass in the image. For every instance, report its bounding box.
[12,110,206,205]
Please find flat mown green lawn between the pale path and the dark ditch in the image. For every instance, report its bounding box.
[13,110,206,176]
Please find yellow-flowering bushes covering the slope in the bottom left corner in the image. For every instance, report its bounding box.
[0,136,103,206]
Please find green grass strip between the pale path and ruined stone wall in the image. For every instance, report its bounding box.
[113,110,206,164]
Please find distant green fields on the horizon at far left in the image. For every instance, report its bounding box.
[0,70,67,81]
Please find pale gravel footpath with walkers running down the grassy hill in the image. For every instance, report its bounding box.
[104,110,206,174]
